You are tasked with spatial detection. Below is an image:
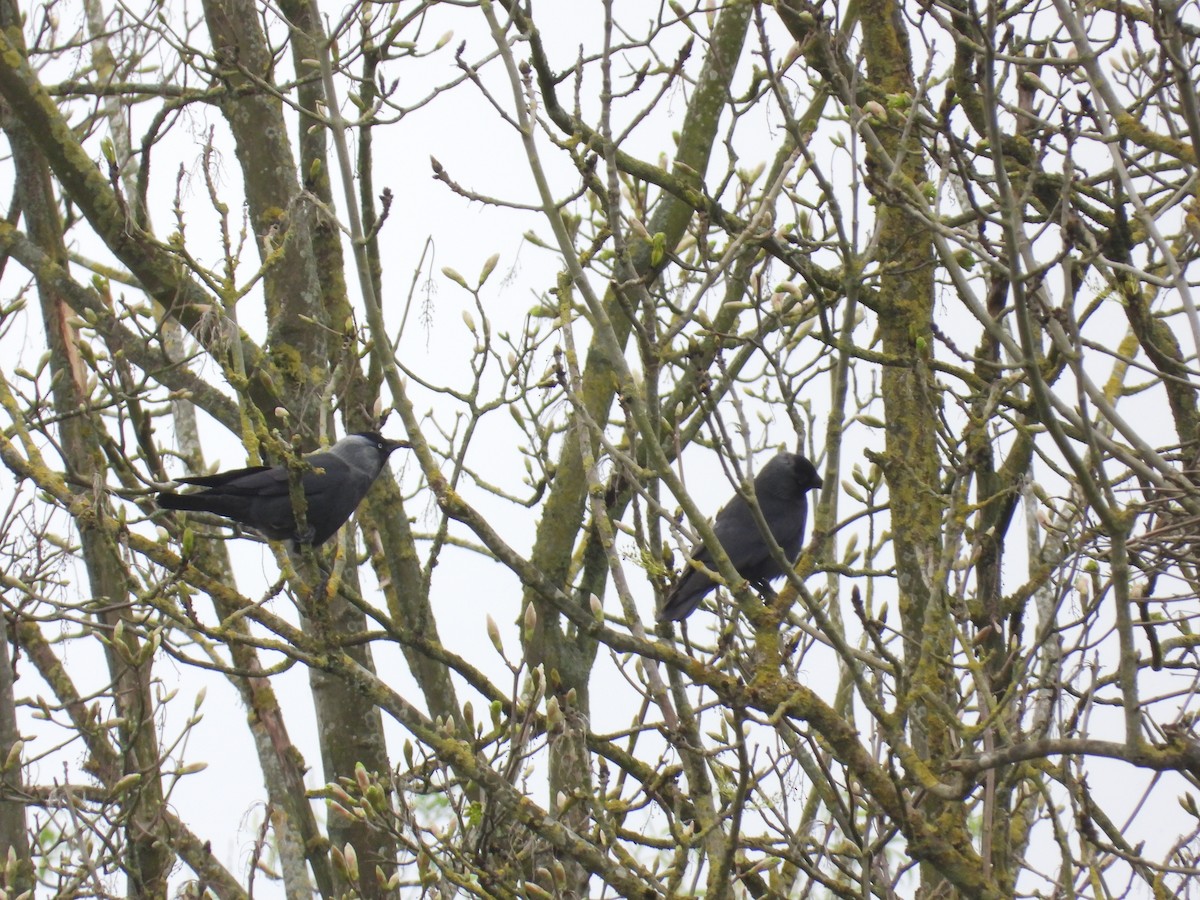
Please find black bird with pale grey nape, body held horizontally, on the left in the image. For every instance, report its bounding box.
[158,431,408,546]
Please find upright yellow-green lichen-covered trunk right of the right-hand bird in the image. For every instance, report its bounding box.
[860,0,966,896]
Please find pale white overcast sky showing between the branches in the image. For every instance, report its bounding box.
[0,2,1192,896]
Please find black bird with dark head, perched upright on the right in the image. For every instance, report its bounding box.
[659,454,822,622]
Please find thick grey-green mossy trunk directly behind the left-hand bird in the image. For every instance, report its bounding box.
[204,0,396,896]
